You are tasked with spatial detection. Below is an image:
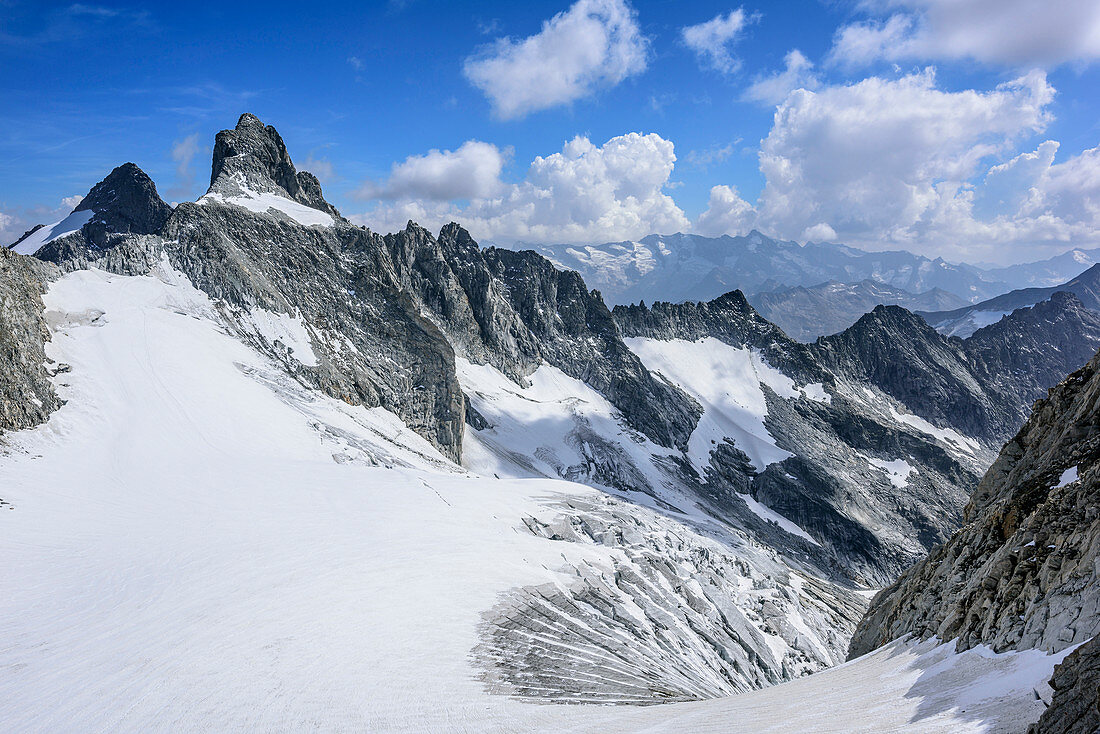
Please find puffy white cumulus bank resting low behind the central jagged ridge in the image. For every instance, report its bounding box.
[352,133,690,243]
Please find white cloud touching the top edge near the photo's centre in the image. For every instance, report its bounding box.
[463,0,649,120]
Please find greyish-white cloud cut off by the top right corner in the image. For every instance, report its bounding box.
[829,0,1100,67]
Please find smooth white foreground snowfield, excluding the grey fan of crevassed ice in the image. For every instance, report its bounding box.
[0,267,1056,732]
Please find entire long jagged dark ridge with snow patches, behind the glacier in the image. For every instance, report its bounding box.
[4,114,1100,598]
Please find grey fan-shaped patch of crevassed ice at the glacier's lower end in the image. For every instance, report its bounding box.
[472,501,861,704]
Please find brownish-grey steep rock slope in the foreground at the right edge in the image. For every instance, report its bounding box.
[850,347,1100,656]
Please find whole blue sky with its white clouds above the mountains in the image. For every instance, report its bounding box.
[0,0,1100,262]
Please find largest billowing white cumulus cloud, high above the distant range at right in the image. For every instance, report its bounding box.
[757,69,1054,250]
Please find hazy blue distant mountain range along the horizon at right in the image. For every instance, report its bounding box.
[514,230,1100,341]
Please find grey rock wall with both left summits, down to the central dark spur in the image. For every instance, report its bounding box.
[25,114,700,460]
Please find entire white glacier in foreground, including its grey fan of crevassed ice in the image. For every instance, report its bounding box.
[0,254,1056,732]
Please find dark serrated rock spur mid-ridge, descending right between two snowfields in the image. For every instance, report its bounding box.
[381,222,701,447]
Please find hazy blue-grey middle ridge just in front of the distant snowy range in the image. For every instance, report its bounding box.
[749,280,966,341]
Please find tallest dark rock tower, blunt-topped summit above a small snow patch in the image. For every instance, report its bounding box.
[210,112,340,217]
